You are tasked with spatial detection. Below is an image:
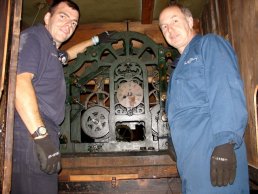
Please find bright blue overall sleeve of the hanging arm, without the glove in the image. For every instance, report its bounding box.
[202,36,247,148]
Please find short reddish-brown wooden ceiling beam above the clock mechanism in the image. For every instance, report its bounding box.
[142,0,155,24]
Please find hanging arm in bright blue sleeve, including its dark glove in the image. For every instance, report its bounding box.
[203,36,247,186]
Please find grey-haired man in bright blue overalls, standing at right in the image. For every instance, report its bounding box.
[159,3,249,194]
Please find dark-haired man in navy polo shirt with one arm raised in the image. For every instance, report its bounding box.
[11,0,116,194]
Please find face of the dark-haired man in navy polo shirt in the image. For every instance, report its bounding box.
[44,2,79,48]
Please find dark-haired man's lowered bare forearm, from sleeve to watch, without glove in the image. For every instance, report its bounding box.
[15,73,44,134]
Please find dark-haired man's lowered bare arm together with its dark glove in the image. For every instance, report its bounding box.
[15,73,61,174]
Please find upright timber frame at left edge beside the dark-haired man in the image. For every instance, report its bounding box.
[0,0,22,193]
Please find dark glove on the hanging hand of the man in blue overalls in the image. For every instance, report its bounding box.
[210,143,236,187]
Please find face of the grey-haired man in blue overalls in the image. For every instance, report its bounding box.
[159,7,194,54]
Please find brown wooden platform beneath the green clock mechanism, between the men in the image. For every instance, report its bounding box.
[59,152,181,194]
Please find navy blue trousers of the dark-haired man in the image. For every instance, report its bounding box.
[11,114,59,194]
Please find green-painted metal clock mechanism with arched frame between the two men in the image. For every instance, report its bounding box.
[61,31,177,153]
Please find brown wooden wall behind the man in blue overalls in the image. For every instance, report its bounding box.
[200,0,258,169]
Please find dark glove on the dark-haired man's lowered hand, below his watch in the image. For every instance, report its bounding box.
[34,135,61,174]
